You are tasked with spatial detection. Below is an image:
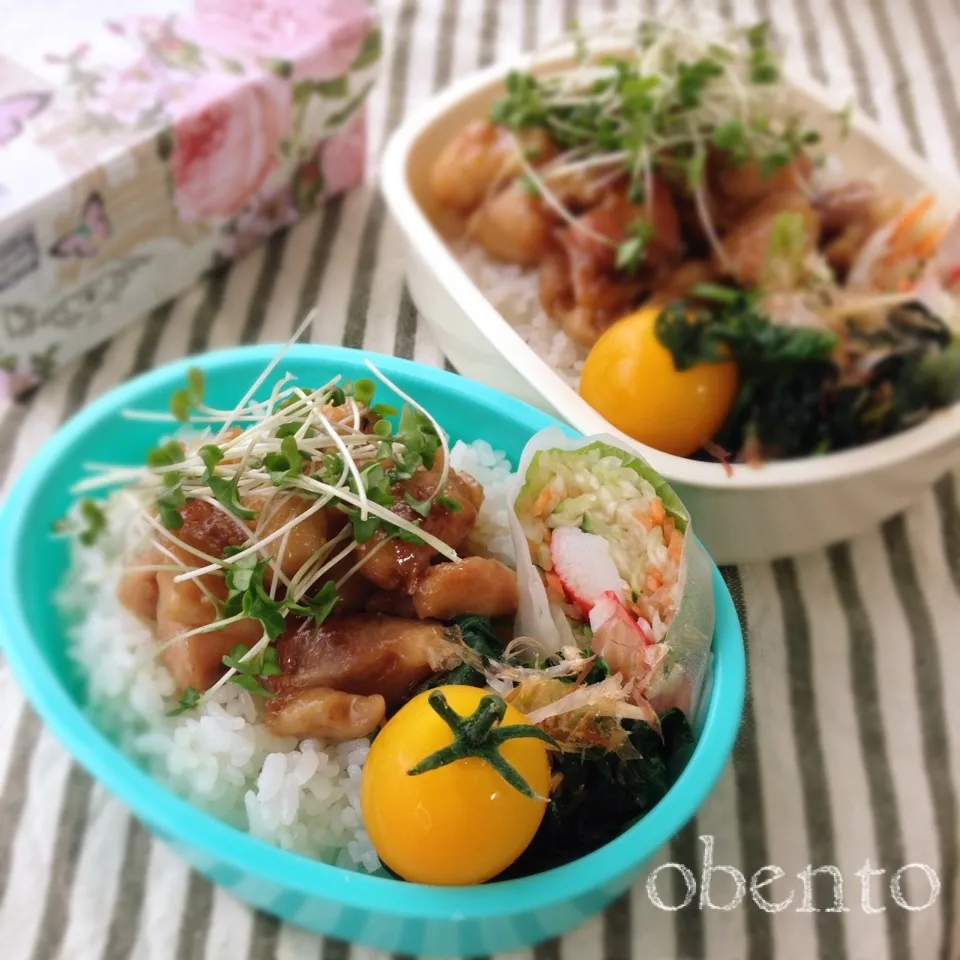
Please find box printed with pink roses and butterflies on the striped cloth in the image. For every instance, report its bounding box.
[0,0,380,403]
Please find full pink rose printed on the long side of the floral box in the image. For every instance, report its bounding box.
[170,73,291,222]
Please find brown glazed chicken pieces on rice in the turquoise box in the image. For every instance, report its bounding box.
[118,403,519,740]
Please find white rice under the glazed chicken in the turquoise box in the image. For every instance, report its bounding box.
[56,441,513,873]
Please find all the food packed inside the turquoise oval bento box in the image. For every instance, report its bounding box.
[58,338,712,884]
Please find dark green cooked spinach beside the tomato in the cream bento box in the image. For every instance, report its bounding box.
[655,288,960,459]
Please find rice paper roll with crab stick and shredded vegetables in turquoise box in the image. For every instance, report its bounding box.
[509,427,714,727]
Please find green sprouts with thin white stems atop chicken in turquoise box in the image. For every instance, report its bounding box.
[63,337,459,715]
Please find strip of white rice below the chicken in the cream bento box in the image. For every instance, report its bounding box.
[451,241,588,390]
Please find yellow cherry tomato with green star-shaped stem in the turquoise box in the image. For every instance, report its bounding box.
[360,685,550,886]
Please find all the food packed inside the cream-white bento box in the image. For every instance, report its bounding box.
[430,11,960,464]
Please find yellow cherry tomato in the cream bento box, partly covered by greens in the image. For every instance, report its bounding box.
[580,305,738,457]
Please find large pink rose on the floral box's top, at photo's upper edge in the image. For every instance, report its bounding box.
[194,0,373,80]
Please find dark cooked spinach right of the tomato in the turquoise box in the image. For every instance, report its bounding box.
[498,710,694,880]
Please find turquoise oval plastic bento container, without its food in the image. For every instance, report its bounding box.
[0,346,745,956]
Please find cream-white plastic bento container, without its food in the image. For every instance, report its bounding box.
[381,41,960,564]
